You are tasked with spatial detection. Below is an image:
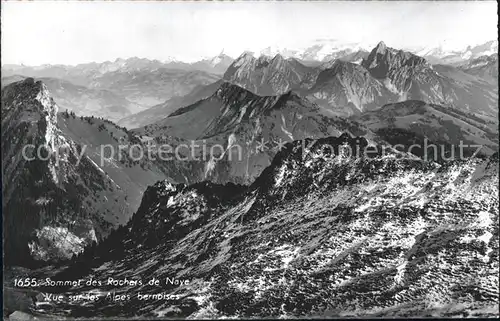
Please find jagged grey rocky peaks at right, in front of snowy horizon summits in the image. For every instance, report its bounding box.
[224,42,498,115]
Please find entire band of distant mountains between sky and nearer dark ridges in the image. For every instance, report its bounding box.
[2,39,498,128]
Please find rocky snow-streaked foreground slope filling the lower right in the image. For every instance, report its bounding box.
[17,135,499,318]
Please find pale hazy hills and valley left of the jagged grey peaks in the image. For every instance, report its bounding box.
[2,53,232,116]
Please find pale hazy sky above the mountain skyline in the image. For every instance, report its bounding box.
[1,1,497,65]
